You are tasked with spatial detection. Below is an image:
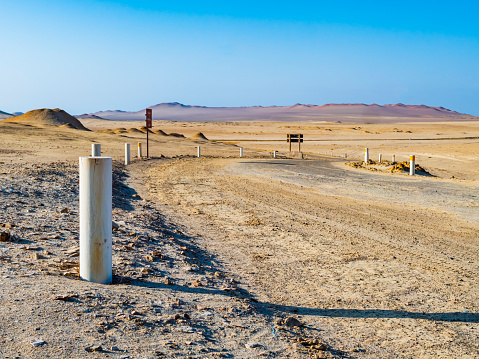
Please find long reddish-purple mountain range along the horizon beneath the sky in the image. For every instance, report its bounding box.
[84,102,479,122]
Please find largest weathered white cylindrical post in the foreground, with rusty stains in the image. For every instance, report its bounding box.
[80,157,112,284]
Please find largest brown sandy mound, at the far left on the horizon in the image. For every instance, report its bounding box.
[4,108,88,131]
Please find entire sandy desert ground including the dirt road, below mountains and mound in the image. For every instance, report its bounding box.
[0,116,479,358]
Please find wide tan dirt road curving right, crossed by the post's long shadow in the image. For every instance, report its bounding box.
[131,158,479,358]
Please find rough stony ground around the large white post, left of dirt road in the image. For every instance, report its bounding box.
[0,159,338,359]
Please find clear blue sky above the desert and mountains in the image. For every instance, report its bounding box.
[0,0,479,115]
